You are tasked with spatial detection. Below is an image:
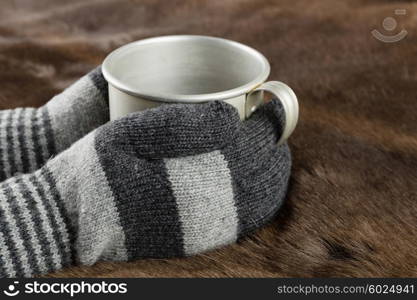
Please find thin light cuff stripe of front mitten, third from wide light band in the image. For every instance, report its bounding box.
[0,178,32,277]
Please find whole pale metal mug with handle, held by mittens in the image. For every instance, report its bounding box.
[102,35,298,144]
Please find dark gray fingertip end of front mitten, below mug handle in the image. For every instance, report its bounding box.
[221,102,291,237]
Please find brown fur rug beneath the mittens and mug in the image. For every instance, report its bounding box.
[0,0,417,277]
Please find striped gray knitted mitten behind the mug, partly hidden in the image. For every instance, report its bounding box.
[0,67,109,181]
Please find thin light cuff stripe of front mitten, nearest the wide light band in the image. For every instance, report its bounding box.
[23,172,62,270]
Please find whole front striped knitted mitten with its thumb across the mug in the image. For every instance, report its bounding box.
[0,101,291,277]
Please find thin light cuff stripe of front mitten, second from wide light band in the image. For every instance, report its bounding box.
[11,176,47,272]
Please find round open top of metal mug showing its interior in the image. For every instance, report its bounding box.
[103,36,270,102]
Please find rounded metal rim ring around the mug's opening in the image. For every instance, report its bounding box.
[101,35,271,103]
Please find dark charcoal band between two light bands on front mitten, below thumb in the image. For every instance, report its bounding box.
[95,124,184,259]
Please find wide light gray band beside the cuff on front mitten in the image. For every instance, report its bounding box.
[48,133,127,265]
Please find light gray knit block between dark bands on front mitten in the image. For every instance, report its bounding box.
[165,151,238,255]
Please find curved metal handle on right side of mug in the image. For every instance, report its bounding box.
[245,81,299,145]
